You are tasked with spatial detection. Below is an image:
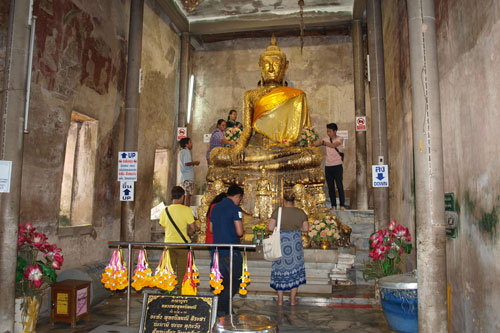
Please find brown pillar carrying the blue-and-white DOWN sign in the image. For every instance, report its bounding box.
[366,0,390,229]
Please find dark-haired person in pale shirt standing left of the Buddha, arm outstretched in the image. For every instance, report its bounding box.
[177,138,200,207]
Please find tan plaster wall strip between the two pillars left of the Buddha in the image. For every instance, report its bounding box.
[135,1,180,241]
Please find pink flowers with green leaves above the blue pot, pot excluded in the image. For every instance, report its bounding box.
[363,220,412,280]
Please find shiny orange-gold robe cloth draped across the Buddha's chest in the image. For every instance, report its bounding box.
[253,87,311,143]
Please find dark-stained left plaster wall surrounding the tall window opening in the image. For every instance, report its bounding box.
[17,0,128,269]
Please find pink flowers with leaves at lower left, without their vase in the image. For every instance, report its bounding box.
[16,222,64,297]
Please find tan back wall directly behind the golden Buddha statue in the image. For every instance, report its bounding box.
[190,37,356,201]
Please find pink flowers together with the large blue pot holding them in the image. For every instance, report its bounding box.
[363,220,418,332]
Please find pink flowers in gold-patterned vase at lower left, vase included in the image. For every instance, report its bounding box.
[15,222,63,332]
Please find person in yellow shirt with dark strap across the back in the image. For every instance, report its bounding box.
[160,186,196,294]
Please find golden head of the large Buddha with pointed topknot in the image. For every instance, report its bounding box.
[259,35,288,83]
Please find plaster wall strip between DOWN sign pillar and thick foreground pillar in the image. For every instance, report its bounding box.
[382,0,415,268]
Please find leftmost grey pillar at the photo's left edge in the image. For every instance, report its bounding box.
[0,0,30,332]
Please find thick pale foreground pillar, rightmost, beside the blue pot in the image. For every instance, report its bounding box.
[407,0,448,333]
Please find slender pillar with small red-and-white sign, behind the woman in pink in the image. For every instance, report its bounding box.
[352,20,368,210]
